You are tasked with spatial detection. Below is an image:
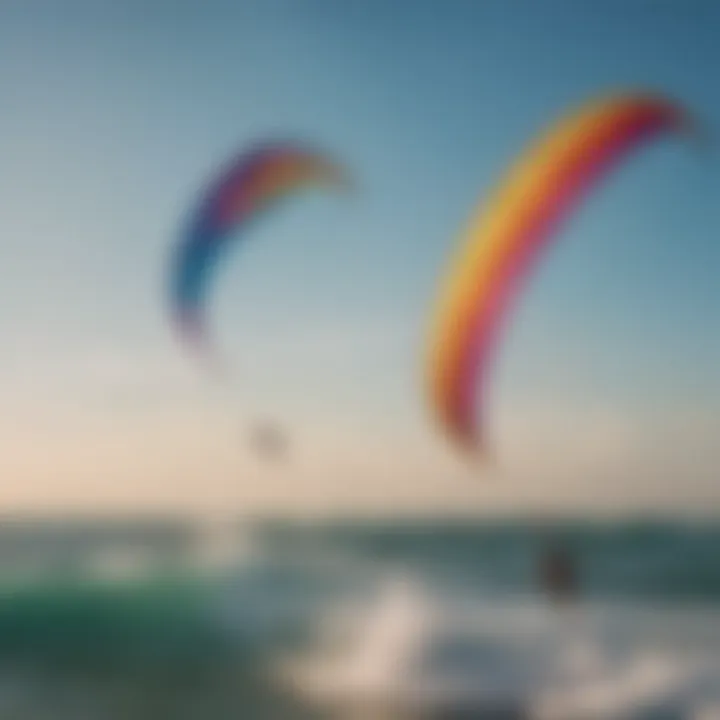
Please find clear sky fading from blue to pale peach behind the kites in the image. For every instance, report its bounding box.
[0,0,720,512]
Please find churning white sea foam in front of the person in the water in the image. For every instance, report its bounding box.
[280,577,720,720]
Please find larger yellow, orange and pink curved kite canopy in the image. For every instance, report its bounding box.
[428,94,690,454]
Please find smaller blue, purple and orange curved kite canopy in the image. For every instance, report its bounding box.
[171,143,347,352]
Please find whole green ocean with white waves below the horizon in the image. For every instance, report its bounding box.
[0,519,720,720]
